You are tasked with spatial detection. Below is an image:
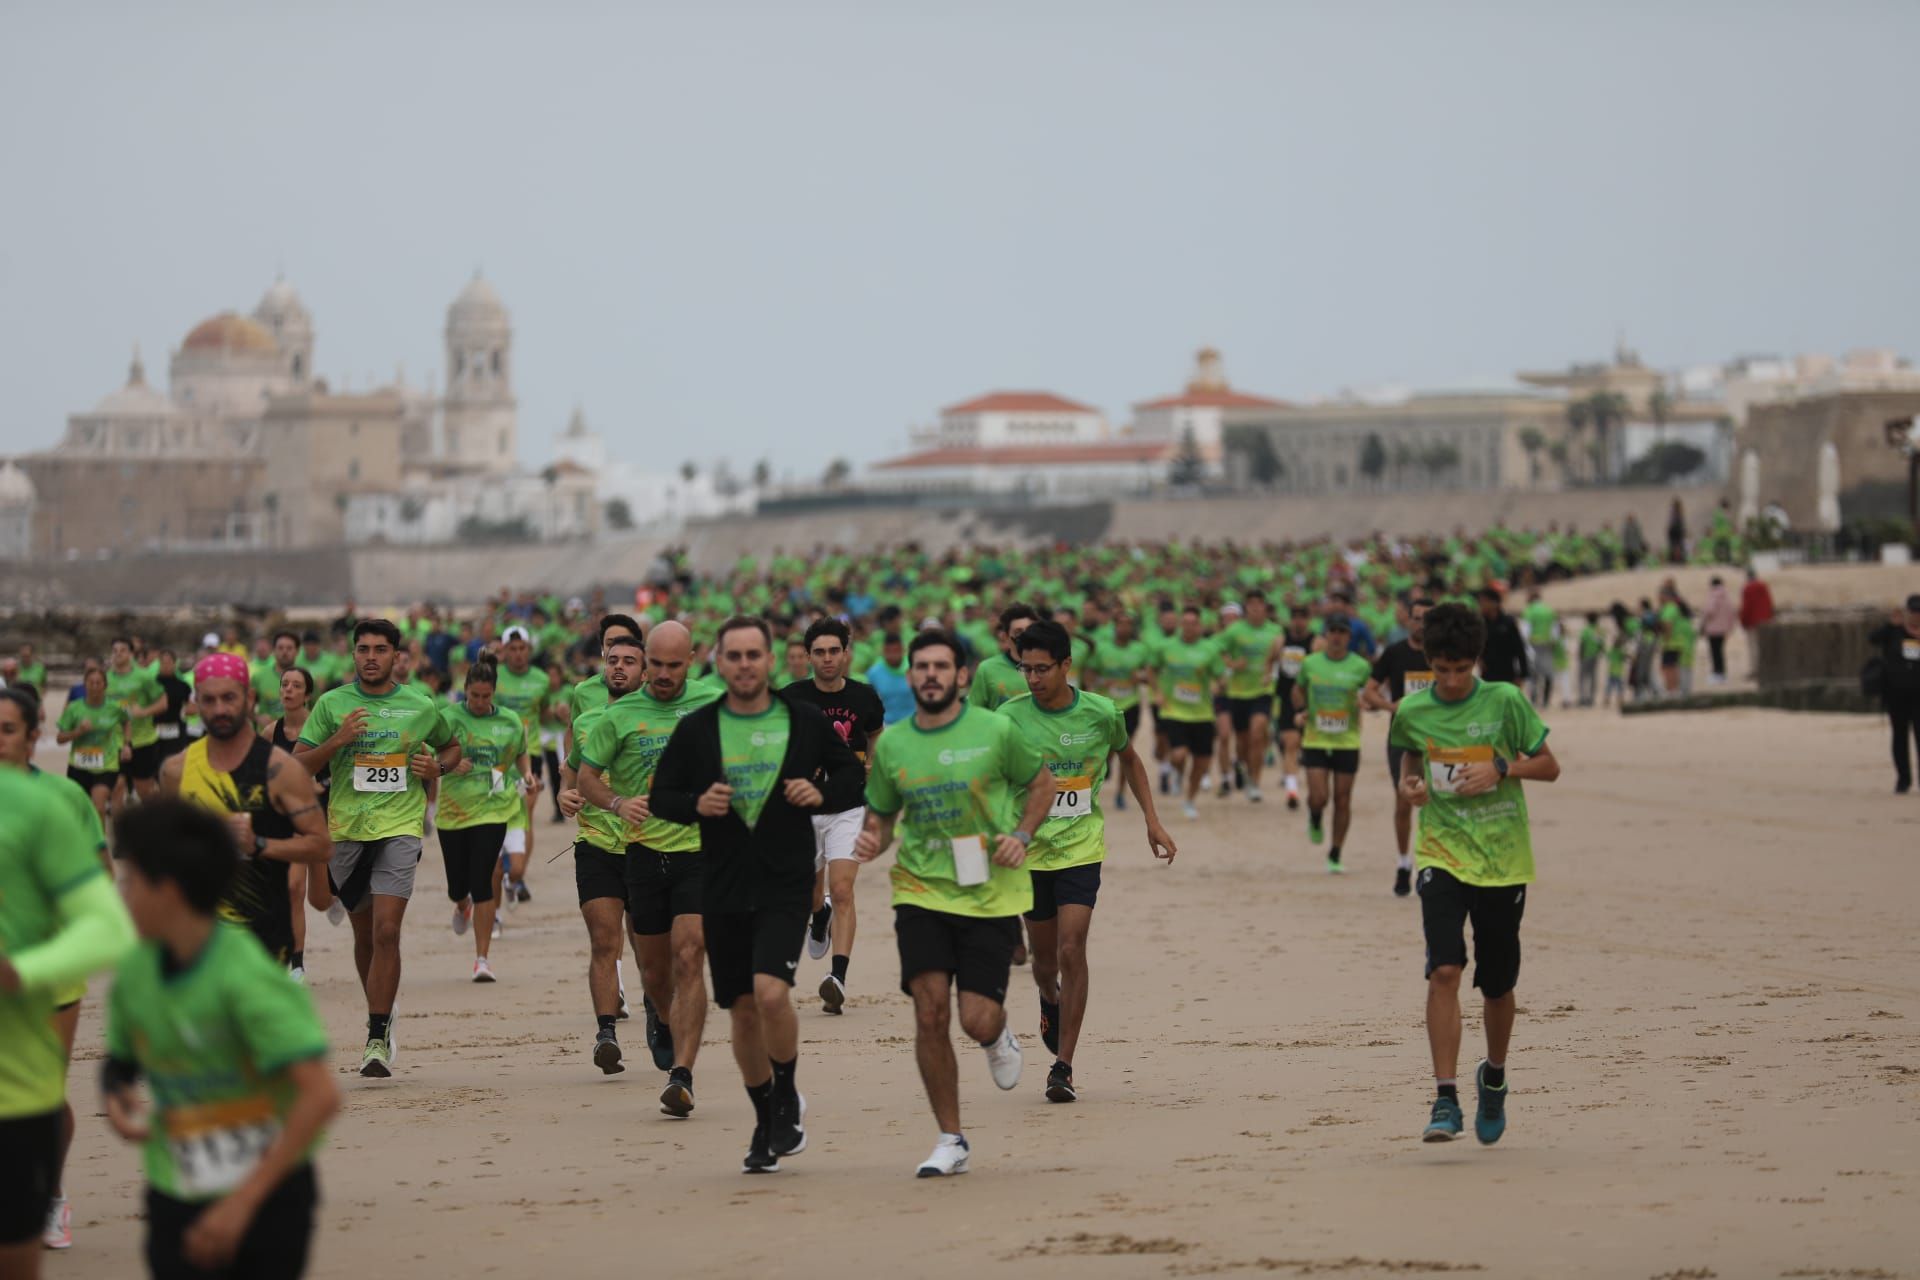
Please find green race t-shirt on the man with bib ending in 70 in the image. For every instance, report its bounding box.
[1000,691,1127,871]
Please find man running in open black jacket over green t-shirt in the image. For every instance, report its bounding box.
[649,618,866,1173]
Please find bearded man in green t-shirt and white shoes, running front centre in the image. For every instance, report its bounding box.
[854,629,1054,1178]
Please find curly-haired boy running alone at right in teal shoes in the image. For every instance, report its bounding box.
[1392,604,1561,1144]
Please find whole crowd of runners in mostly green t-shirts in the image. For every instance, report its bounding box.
[0,530,1896,1276]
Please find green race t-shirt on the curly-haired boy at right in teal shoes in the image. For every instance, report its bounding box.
[1388,679,1548,887]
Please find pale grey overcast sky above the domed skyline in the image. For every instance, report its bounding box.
[0,0,1920,474]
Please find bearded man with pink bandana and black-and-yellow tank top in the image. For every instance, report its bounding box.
[159,652,332,965]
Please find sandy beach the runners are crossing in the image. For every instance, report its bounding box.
[42,710,1920,1280]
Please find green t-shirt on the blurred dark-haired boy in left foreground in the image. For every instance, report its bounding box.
[108,921,328,1201]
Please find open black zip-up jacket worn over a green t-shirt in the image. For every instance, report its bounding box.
[647,689,866,913]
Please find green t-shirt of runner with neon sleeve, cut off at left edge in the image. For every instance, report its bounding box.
[0,768,106,1121]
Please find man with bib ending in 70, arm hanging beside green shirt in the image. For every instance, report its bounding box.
[1000,622,1179,1102]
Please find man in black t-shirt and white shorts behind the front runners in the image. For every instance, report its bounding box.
[785,618,887,1013]
